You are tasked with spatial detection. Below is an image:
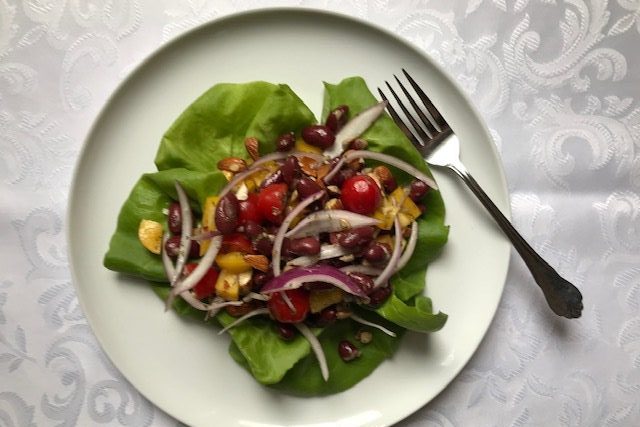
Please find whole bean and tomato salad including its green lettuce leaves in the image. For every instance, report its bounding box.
[104,77,448,395]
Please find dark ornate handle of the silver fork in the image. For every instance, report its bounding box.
[449,163,583,319]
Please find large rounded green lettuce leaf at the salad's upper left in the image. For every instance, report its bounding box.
[155,82,315,171]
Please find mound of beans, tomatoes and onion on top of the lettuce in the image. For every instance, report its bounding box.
[138,103,436,380]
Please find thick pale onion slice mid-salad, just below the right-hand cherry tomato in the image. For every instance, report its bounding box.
[285,209,379,238]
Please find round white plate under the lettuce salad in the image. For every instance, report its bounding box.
[68,9,509,426]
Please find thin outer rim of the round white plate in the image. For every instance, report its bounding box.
[65,6,512,425]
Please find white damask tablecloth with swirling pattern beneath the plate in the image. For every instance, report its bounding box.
[0,0,640,426]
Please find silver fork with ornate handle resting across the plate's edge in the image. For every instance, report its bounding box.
[378,69,583,319]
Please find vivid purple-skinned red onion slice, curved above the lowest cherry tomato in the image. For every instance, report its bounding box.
[260,264,368,300]
